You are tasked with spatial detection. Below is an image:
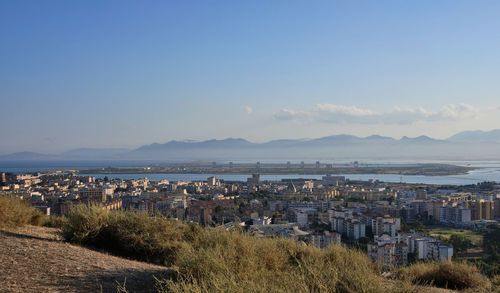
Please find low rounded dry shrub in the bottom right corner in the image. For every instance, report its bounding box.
[396,262,491,291]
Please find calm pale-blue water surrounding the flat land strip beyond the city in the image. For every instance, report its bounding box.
[0,161,500,185]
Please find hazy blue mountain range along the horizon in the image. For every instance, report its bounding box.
[0,129,500,161]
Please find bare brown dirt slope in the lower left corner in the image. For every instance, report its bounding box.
[0,226,166,292]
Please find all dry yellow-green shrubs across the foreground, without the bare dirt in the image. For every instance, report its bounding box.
[0,201,494,293]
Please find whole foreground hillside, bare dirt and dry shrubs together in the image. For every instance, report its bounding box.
[0,196,488,293]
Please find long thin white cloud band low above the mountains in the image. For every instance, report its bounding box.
[274,104,481,125]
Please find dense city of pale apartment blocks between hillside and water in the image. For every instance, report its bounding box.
[0,170,500,268]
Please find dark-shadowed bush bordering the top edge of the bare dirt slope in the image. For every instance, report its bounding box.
[62,205,193,265]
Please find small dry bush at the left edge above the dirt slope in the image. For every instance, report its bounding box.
[0,195,45,228]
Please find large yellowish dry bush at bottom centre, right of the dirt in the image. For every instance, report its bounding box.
[160,229,381,292]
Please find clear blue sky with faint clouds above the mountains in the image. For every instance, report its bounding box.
[0,0,500,154]
